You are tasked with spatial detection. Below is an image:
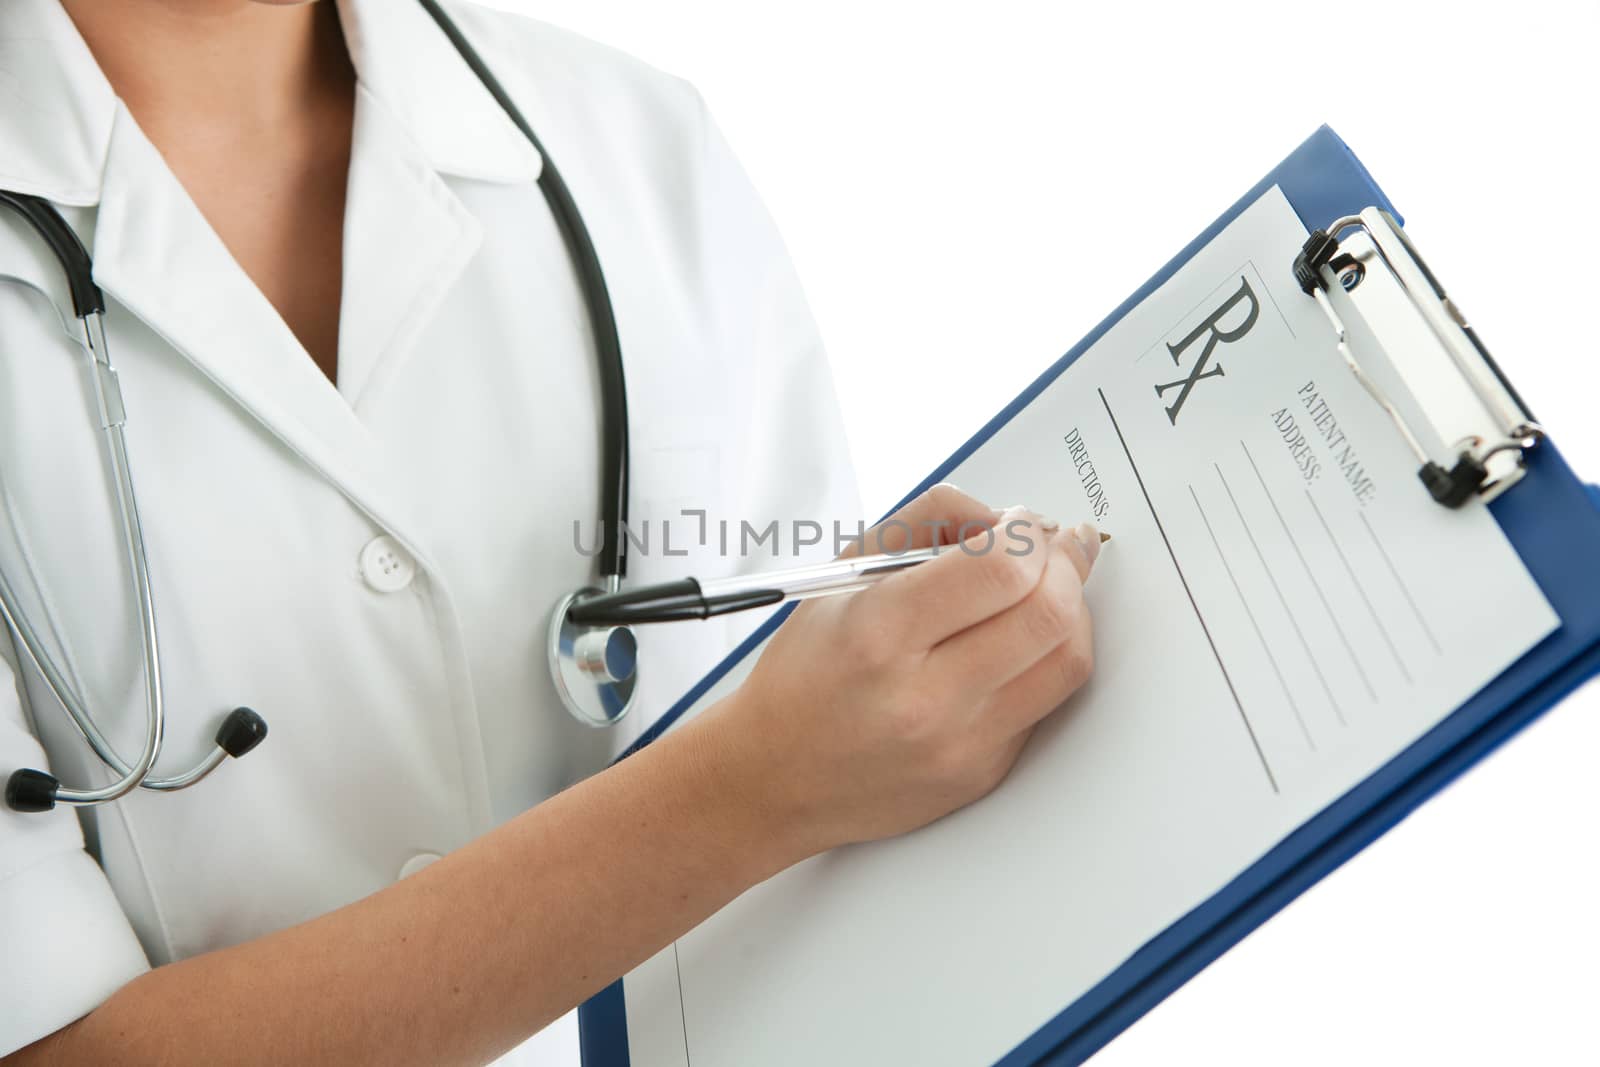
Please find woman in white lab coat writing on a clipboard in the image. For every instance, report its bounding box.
[0,0,1093,1064]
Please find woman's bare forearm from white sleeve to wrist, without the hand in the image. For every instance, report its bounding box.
[16,710,787,1064]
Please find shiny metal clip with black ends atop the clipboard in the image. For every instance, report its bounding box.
[1294,208,1544,507]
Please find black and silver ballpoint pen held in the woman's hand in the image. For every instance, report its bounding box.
[566,533,1110,625]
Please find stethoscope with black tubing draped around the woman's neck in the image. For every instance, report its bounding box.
[0,0,642,811]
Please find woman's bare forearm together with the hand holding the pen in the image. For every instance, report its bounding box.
[6,486,1099,1064]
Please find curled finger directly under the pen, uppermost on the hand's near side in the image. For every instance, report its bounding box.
[854,509,1056,651]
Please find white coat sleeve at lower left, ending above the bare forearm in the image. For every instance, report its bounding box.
[0,640,149,1056]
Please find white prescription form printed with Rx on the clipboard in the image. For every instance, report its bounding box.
[624,189,1558,1067]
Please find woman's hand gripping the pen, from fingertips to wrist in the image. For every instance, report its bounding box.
[698,485,1099,856]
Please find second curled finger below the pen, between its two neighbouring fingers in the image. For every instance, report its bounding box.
[928,531,1099,699]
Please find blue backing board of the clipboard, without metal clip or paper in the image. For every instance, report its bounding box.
[579,126,1600,1067]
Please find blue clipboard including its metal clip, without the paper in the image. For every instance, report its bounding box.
[579,126,1600,1067]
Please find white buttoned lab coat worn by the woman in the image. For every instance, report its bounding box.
[0,0,858,1054]
